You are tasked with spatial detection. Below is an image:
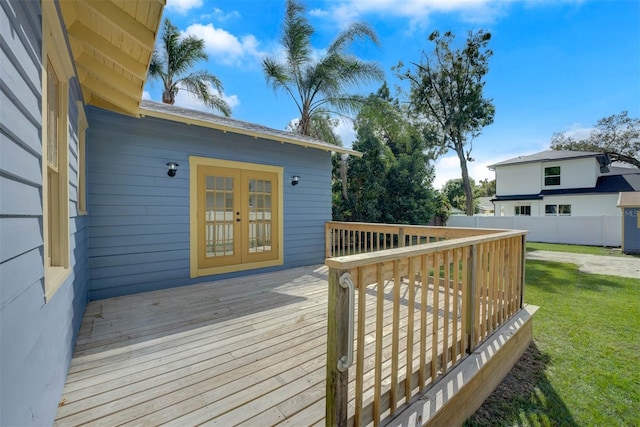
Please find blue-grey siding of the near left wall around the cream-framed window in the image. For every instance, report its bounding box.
[0,0,88,426]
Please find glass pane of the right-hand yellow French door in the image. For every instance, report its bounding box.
[247,179,271,253]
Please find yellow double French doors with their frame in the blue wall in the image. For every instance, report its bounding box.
[189,156,284,277]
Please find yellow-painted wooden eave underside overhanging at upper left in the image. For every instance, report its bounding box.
[59,0,165,116]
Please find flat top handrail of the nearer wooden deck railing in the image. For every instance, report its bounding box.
[324,230,528,270]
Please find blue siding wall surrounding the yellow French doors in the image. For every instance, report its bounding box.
[87,108,331,299]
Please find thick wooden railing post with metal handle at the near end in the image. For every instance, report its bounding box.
[325,268,350,426]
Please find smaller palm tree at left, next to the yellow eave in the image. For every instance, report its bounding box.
[149,19,231,117]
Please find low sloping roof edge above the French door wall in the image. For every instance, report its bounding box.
[139,100,362,157]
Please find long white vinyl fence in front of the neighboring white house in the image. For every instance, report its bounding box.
[447,215,622,247]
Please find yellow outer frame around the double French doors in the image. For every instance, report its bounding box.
[189,156,284,278]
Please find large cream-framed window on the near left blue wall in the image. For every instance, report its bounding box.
[42,1,74,301]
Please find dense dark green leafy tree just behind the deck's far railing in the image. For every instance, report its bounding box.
[334,84,438,224]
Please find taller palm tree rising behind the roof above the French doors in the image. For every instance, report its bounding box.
[262,0,384,137]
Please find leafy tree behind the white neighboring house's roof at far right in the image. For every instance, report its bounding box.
[551,111,640,168]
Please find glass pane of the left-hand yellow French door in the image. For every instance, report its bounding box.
[205,176,234,258]
